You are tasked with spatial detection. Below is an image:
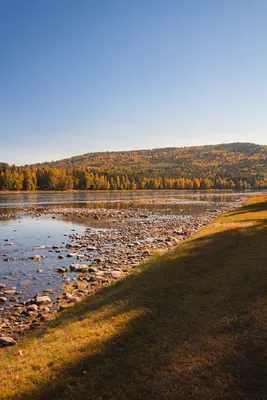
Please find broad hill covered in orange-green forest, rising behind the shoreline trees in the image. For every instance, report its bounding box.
[33,143,267,177]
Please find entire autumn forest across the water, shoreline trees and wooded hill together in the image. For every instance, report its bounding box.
[0,143,267,191]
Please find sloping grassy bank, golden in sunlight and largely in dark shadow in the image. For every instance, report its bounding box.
[0,195,267,400]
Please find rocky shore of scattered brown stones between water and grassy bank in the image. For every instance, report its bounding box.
[0,197,244,347]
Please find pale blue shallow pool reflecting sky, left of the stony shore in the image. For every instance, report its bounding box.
[0,215,104,299]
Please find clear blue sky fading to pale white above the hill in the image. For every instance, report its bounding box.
[0,0,267,164]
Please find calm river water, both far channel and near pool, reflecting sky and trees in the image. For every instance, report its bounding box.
[0,191,262,309]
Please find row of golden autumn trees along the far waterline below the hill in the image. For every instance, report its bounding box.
[0,163,267,191]
